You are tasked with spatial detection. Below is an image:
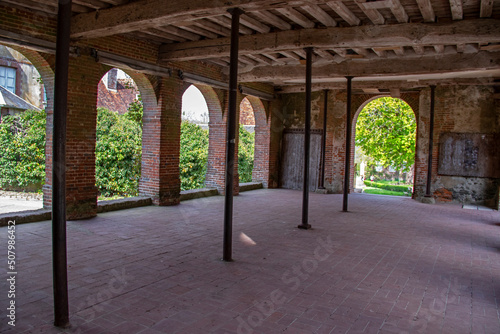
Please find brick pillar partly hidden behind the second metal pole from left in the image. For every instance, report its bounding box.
[205,91,243,195]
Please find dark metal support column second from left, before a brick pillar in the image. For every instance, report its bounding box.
[222,8,243,261]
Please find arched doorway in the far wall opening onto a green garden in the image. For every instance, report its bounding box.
[351,97,417,196]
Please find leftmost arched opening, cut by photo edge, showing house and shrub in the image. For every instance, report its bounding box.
[0,45,53,212]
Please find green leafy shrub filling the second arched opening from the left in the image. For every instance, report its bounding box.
[96,108,142,196]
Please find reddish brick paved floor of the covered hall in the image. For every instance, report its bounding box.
[0,190,500,334]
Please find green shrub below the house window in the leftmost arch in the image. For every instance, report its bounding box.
[0,110,46,191]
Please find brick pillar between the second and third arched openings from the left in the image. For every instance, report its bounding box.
[139,77,184,205]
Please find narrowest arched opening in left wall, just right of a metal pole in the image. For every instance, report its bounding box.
[238,97,255,183]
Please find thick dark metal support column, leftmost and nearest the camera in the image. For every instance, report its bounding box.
[52,0,72,328]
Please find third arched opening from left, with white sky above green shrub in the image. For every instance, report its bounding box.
[179,85,210,190]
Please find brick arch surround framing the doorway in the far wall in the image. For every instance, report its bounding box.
[349,92,420,196]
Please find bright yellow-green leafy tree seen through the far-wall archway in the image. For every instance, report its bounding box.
[356,97,417,172]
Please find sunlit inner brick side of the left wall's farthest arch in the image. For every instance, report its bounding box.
[241,95,271,188]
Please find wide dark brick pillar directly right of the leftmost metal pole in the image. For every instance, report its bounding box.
[66,56,106,220]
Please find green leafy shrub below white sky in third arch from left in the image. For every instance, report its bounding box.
[179,121,208,190]
